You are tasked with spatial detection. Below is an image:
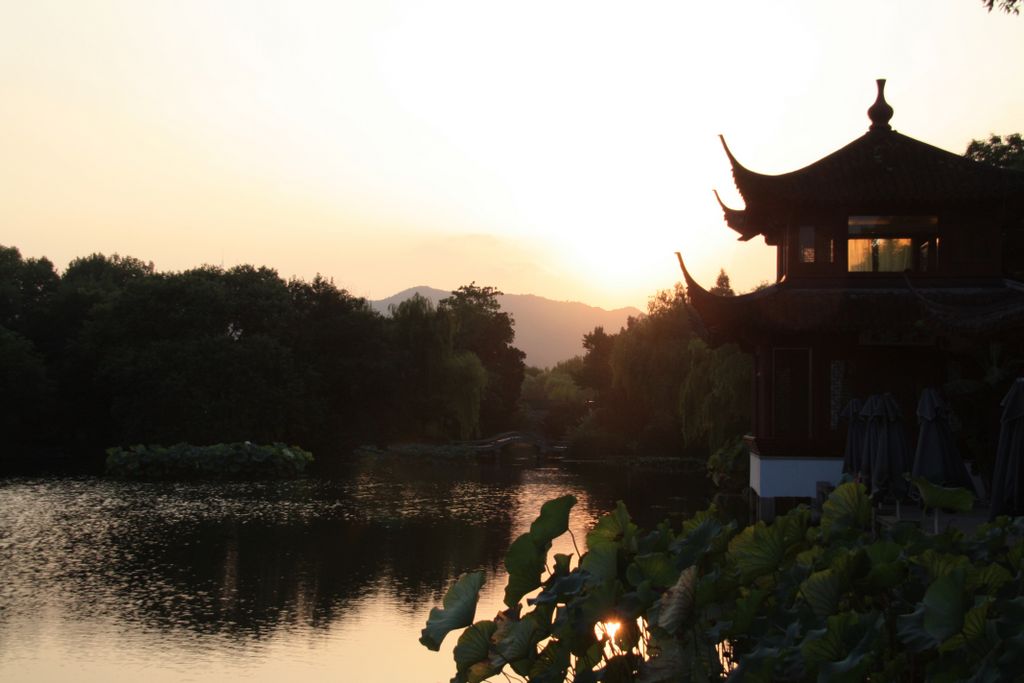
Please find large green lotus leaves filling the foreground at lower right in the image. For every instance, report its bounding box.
[421,482,1024,683]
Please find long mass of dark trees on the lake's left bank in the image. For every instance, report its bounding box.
[0,247,524,453]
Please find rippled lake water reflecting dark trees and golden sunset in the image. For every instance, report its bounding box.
[0,460,711,683]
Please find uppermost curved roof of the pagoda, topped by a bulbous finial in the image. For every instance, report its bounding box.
[722,80,1024,240]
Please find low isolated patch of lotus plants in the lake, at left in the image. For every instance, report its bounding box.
[106,441,313,479]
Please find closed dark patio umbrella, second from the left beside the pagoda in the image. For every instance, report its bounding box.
[860,393,911,501]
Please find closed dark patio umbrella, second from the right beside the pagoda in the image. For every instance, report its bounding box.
[911,387,974,492]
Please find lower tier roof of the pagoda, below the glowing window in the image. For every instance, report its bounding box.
[679,256,1024,343]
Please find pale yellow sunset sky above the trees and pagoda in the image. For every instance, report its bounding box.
[0,0,1024,308]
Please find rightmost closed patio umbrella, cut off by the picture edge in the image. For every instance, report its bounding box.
[989,378,1024,518]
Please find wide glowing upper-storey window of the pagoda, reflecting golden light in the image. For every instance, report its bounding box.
[847,216,938,272]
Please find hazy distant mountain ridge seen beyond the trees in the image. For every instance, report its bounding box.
[370,285,642,368]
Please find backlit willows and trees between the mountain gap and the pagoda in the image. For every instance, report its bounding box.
[570,280,753,464]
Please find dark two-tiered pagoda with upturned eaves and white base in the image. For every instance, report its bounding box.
[679,80,1024,516]
